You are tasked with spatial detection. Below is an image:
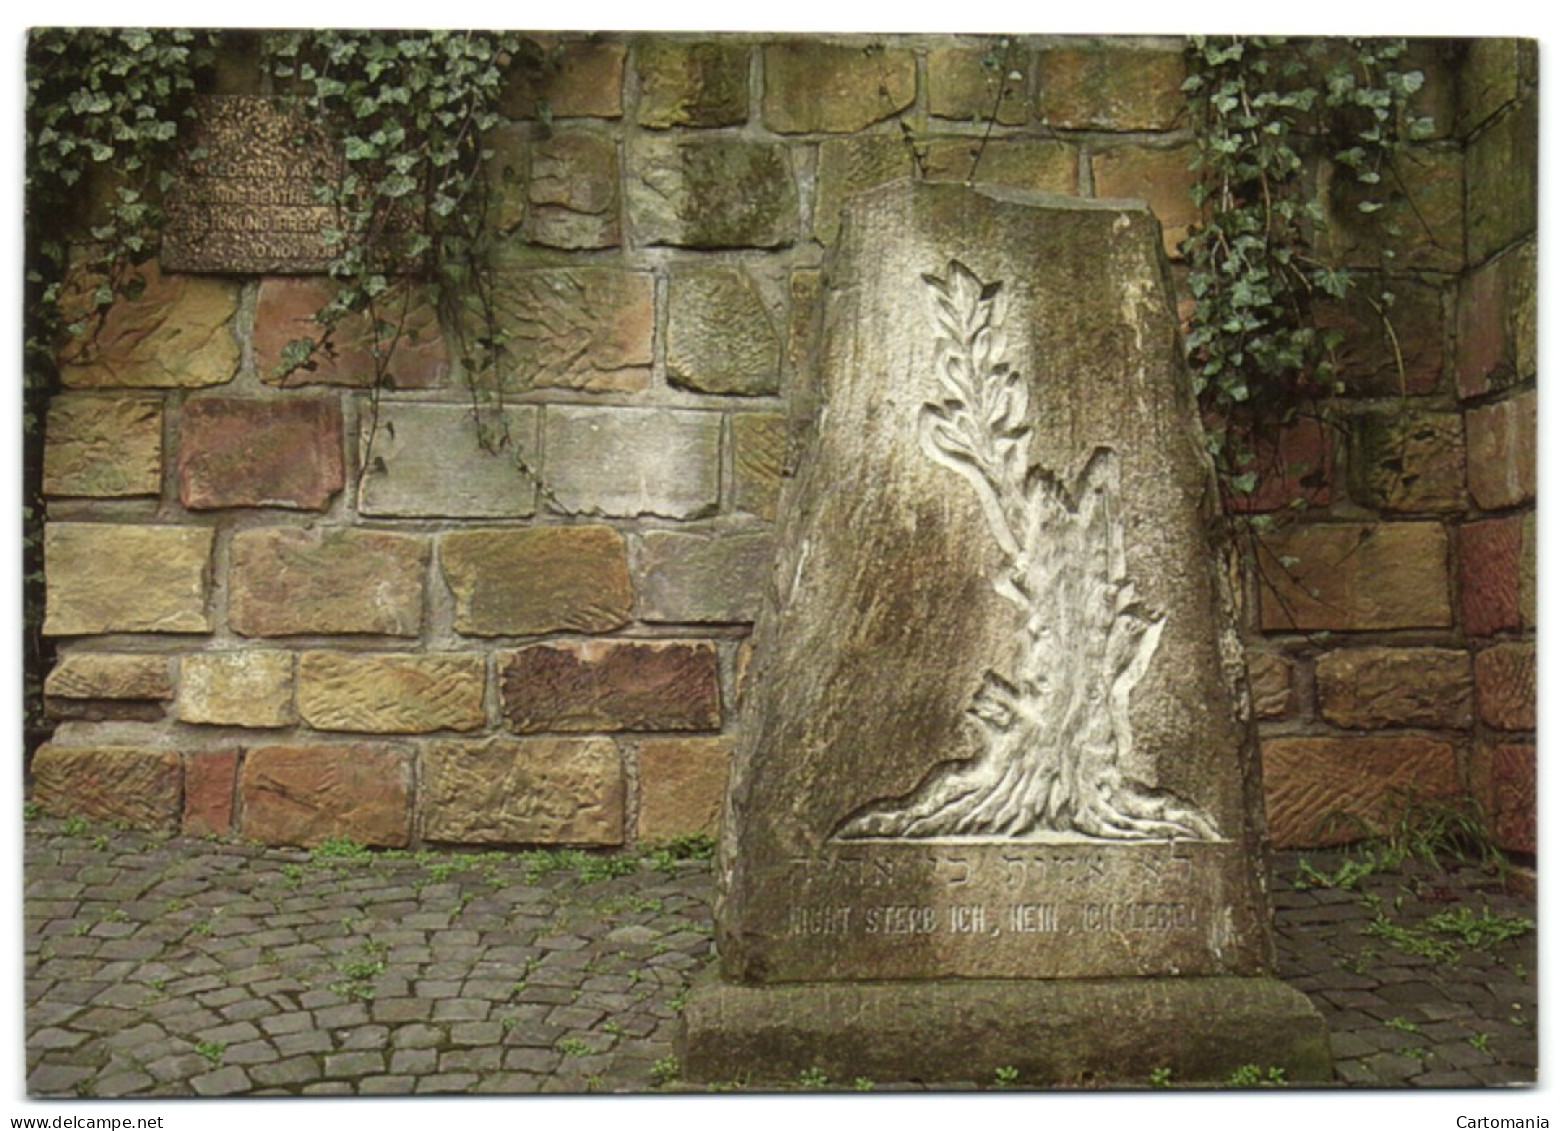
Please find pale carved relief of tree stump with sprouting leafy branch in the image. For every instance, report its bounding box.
[835,259,1218,839]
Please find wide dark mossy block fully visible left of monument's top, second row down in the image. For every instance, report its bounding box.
[627,137,800,250]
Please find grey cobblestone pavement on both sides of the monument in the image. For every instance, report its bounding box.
[25,821,1537,1097]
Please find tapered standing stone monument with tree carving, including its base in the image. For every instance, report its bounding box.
[683,181,1331,1084]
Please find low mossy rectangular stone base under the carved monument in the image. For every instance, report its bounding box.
[679,977,1332,1087]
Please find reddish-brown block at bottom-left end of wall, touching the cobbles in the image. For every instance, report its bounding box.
[33,743,184,833]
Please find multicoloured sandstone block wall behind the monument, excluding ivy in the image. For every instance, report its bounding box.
[31,36,1537,850]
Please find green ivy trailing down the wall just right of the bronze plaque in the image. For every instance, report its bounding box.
[267,31,541,449]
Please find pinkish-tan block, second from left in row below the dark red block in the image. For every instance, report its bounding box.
[228,527,427,636]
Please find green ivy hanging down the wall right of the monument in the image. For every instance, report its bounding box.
[1182,36,1432,514]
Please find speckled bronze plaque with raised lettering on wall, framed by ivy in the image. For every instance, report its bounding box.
[162,95,343,275]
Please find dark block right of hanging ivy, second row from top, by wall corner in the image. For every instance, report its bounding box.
[1320,145,1463,271]
